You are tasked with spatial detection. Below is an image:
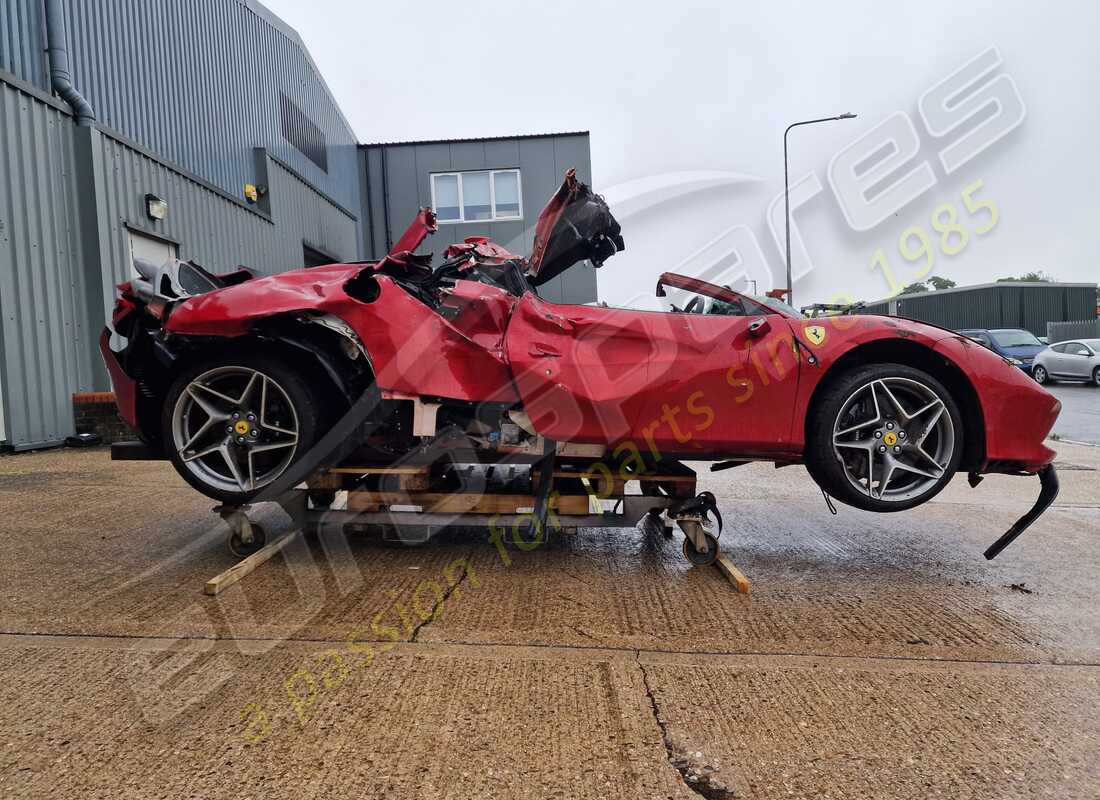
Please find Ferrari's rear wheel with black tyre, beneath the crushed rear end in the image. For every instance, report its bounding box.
[161,351,322,504]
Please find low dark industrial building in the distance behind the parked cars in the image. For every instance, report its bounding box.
[861,281,1097,341]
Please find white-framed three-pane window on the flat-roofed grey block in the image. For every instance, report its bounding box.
[431,169,524,222]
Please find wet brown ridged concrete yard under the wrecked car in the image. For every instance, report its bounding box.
[0,443,1100,800]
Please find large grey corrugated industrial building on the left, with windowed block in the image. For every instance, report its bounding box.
[0,0,595,449]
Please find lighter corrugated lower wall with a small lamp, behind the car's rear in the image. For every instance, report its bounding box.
[98,128,358,306]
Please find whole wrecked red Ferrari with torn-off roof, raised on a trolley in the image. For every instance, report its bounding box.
[101,171,1059,555]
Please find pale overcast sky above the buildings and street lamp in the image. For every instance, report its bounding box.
[265,0,1100,300]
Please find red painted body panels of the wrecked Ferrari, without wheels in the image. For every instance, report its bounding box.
[141,253,1060,472]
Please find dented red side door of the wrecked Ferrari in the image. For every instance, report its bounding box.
[505,287,799,459]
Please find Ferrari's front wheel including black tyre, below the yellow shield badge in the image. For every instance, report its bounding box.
[805,363,964,512]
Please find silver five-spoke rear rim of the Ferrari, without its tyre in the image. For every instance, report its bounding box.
[172,366,298,492]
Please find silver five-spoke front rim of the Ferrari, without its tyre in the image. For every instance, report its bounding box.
[833,377,955,503]
